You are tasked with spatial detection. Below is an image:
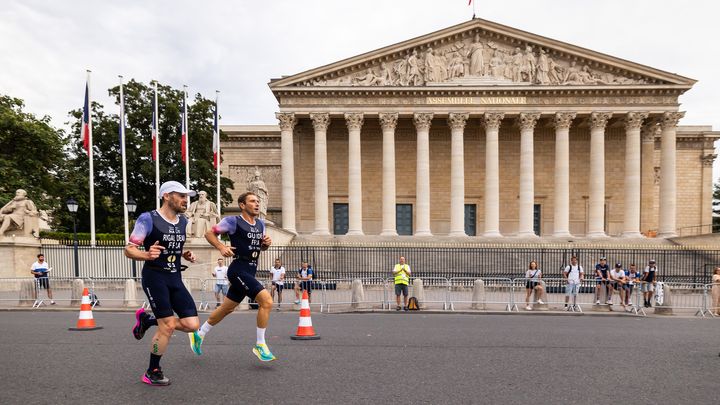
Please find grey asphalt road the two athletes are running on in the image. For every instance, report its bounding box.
[0,311,720,405]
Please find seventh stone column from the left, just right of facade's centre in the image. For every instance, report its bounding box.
[483,113,505,238]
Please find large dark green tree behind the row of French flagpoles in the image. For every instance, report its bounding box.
[57,80,233,233]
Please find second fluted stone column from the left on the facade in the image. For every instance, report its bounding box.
[310,113,330,236]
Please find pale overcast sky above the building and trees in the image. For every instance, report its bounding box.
[0,0,720,178]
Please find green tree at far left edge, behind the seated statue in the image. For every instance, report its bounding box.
[0,95,65,210]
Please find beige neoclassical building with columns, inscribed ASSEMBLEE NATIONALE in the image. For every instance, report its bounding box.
[222,19,720,238]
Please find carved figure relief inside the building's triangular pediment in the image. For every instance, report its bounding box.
[297,30,645,87]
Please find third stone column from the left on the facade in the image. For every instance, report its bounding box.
[345,113,363,235]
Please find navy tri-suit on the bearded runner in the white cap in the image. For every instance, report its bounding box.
[130,210,197,318]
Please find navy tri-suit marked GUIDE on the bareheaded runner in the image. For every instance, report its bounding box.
[212,215,265,302]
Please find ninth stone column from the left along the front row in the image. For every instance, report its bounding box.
[553,112,576,238]
